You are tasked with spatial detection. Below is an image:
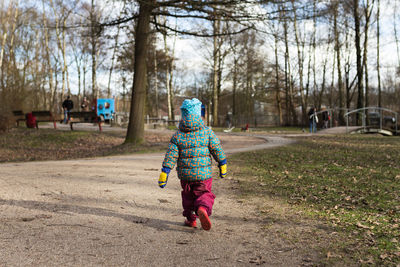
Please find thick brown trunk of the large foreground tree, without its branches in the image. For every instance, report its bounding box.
[125,0,155,144]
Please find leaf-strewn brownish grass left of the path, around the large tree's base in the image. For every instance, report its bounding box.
[0,127,171,162]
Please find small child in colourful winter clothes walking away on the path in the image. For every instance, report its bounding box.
[158,98,227,230]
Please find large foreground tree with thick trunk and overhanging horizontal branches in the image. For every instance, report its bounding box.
[118,0,260,143]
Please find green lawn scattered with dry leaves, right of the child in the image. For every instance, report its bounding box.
[230,135,400,266]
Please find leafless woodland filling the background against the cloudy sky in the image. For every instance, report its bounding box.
[0,0,400,142]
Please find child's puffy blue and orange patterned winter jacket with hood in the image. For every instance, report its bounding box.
[162,115,226,181]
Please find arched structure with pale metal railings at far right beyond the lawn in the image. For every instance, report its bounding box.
[344,107,398,135]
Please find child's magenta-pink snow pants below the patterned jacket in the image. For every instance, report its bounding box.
[181,178,215,221]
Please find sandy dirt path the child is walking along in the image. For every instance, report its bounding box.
[0,135,324,266]
